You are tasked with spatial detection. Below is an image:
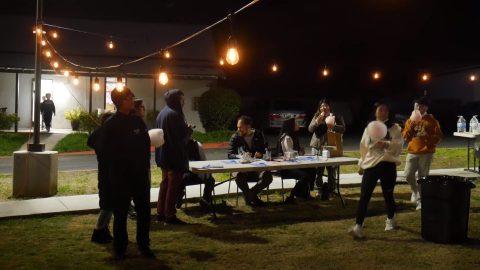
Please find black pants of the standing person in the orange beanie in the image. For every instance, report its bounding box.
[112,168,150,253]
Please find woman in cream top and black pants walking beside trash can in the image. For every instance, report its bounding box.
[350,103,403,238]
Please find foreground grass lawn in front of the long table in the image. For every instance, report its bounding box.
[0,185,480,269]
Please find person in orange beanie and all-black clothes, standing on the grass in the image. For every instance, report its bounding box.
[100,88,155,260]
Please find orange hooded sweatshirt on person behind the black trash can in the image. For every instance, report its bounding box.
[403,114,443,154]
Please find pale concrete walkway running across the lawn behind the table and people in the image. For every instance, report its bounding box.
[0,169,480,219]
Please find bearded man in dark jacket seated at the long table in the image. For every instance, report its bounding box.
[228,116,273,206]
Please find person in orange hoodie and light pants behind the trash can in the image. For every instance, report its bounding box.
[403,97,443,210]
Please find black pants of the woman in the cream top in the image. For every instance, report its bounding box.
[356,162,397,225]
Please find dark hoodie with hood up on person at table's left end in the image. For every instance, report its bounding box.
[155,89,193,171]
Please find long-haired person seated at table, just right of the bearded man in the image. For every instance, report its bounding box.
[277,118,316,204]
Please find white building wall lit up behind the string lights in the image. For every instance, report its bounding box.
[0,72,210,132]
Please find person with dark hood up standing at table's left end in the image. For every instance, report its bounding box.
[155,89,193,225]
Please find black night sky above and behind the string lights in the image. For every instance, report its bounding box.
[0,0,480,98]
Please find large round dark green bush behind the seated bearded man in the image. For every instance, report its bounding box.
[198,88,240,132]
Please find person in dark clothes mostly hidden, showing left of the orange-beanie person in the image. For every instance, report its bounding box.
[87,112,113,244]
